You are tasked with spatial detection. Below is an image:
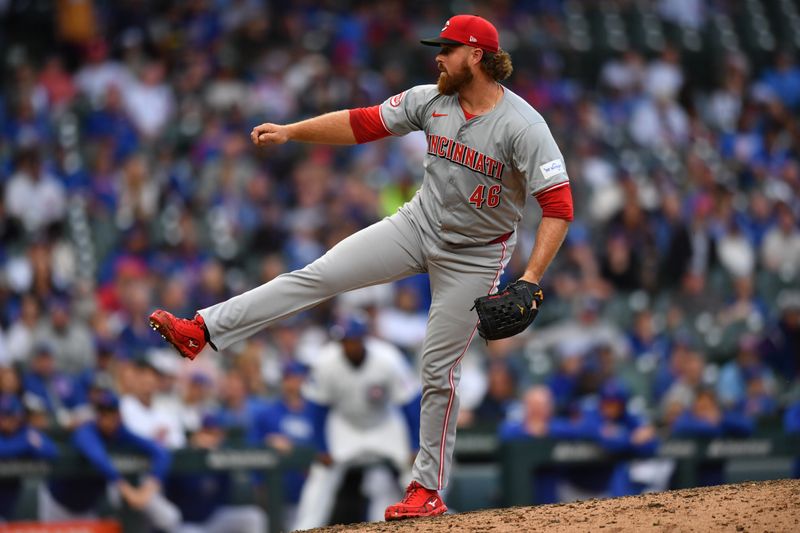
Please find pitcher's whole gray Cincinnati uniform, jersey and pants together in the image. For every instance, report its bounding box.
[199,85,568,489]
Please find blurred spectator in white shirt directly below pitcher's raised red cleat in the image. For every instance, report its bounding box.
[120,358,186,449]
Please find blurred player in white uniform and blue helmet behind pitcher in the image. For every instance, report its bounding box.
[294,315,420,529]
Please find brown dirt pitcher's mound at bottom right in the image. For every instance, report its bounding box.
[302,479,800,533]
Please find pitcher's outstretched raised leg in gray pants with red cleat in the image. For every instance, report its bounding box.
[150,213,424,359]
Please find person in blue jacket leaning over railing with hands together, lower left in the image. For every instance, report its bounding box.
[39,391,181,532]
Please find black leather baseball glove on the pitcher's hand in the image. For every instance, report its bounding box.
[474,280,544,341]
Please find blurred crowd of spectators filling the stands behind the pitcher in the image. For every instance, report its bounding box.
[0,0,800,524]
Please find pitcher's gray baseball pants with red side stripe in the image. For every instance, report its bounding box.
[199,209,514,490]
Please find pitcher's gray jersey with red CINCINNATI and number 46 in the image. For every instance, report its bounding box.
[380,85,568,245]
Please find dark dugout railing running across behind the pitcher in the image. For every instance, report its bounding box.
[0,431,800,524]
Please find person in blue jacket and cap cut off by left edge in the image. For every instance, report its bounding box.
[0,394,58,522]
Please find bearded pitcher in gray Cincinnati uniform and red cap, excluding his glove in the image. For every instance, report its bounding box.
[150,15,573,520]
